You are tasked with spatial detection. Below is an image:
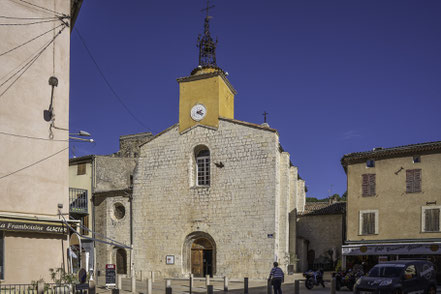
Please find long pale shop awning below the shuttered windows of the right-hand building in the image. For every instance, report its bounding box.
[342,244,441,255]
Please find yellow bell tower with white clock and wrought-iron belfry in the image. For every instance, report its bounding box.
[178,0,237,132]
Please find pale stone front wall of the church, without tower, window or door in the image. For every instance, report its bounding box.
[133,120,296,278]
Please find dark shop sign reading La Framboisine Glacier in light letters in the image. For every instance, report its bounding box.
[0,218,68,234]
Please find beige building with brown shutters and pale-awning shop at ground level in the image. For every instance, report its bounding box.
[341,142,441,278]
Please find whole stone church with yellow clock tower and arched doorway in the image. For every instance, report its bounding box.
[129,12,305,278]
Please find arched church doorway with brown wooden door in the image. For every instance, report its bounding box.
[184,232,216,277]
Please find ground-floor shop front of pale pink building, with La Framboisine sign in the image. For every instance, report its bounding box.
[0,215,68,284]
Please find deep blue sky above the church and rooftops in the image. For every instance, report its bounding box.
[70,0,441,198]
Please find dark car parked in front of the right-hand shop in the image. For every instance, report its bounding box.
[354,260,436,294]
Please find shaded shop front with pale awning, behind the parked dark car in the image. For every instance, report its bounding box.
[342,240,441,284]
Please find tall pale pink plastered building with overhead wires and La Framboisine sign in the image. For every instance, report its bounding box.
[0,0,82,283]
